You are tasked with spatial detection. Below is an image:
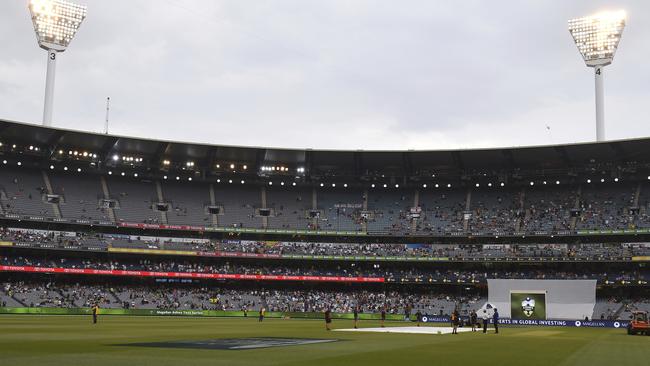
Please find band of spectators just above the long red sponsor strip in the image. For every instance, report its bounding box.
[0,255,650,284]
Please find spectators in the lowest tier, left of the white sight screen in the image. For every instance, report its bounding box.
[0,281,476,315]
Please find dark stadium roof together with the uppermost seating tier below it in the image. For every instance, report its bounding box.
[0,121,650,240]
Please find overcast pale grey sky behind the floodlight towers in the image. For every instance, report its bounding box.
[0,0,650,149]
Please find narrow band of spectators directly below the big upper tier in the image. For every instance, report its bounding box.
[0,228,650,261]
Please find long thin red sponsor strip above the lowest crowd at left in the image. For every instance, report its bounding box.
[0,266,384,283]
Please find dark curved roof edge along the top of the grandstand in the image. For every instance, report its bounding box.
[0,120,650,177]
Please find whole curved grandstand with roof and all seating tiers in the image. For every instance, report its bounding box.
[0,121,650,319]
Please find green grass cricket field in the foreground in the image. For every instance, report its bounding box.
[0,315,650,366]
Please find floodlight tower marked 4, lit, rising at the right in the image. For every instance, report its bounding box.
[569,10,626,141]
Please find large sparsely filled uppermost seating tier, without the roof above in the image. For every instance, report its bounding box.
[0,164,650,237]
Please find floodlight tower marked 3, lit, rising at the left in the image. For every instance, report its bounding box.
[29,0,86,126]
